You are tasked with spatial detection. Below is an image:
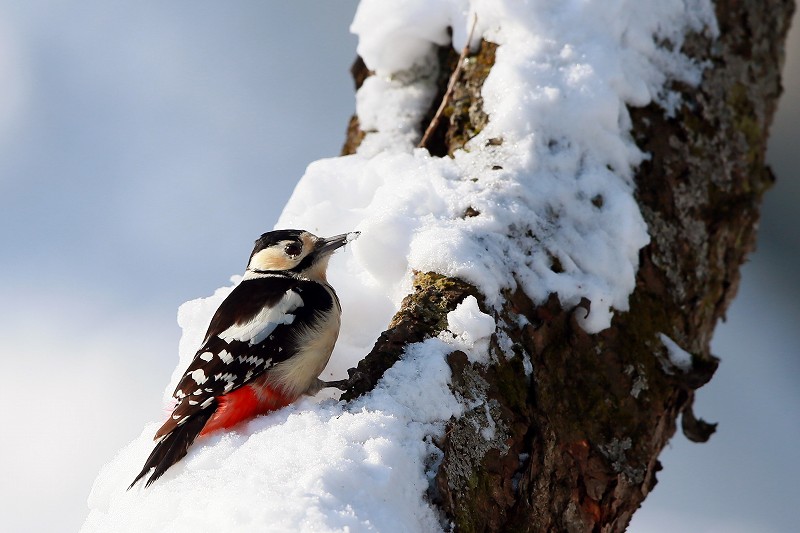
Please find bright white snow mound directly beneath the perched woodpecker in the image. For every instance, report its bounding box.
[84,339,461,532]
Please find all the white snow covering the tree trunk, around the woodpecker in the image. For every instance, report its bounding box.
[83,0,716,532]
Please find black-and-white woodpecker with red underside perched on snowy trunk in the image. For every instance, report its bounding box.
[133,230,359,489]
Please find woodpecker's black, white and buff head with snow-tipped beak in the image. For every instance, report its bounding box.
[242,229,360,281]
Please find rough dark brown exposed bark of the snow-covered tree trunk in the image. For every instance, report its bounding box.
[334,0,793,532]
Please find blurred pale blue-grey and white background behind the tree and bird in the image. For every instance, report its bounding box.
[0,0,800,532]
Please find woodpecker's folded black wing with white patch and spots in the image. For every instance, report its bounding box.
[156,276,310,439]
